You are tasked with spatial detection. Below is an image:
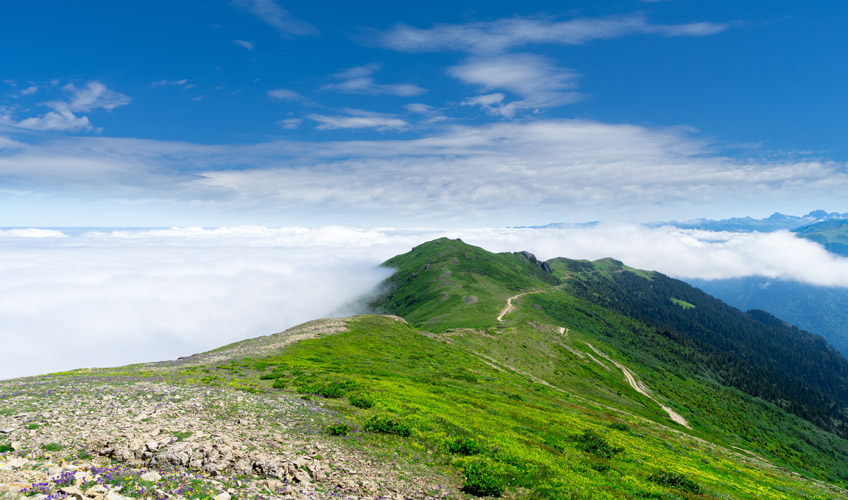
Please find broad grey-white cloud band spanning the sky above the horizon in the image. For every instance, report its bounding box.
[0,119,848,225]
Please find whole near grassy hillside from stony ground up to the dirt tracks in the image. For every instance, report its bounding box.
[149,316,844,499]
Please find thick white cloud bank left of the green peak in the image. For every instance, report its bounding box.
[0,227,394,378]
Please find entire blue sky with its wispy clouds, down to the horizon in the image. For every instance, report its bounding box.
[0,0,848,227]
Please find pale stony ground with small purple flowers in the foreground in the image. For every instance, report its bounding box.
[0,375,464,500]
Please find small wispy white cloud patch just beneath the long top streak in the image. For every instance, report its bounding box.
[448,54,580,117]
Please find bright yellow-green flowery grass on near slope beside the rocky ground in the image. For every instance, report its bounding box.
[192,316,848,499]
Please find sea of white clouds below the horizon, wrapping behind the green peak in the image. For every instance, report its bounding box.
[0,224,848,379]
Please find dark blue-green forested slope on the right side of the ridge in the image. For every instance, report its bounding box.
[552,260,848,437]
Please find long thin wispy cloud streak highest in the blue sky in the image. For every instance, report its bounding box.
[380,15,734,53]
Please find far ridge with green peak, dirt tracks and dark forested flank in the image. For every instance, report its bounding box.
[377,240,848,488]
